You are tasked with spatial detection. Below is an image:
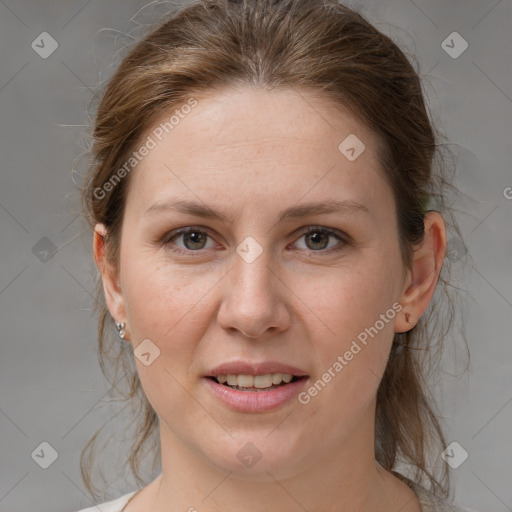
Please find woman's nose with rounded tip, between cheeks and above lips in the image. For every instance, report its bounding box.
[217,243,291,339]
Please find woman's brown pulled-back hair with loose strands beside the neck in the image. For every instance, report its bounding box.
[80,0,466,502]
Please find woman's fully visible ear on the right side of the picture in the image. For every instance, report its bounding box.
[395,211,446,332]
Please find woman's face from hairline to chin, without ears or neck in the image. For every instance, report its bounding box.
[102,88,406,478]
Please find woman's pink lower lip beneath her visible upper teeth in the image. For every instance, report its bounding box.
[204,377,308,412]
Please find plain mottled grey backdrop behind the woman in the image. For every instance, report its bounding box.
[0,0,512,512]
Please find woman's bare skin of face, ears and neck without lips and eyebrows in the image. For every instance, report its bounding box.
[94,87,446,512]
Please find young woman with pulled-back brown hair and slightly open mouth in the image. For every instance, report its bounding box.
[76,0,472,512]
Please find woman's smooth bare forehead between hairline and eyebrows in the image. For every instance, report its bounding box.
[128,87,385,216]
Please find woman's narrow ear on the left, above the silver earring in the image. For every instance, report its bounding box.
[93,224,129,341]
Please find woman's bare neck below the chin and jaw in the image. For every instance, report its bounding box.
[141,404,419,512]
